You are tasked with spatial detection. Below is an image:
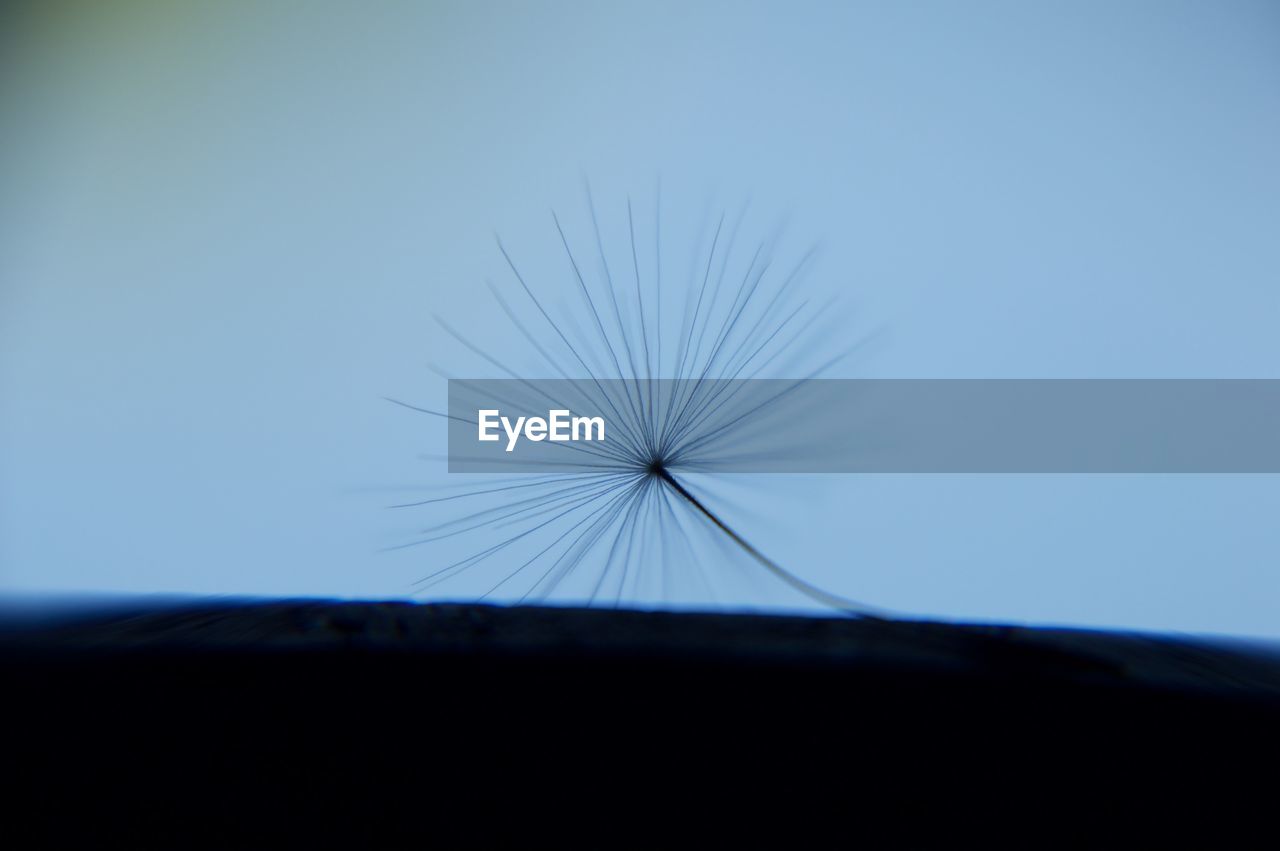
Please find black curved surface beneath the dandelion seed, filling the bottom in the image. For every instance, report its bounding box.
[0,601,1280,848]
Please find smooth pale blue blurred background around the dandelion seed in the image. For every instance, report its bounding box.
[0,0,1280,636]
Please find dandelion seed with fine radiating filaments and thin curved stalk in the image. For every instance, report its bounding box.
[398,185,870,614]
